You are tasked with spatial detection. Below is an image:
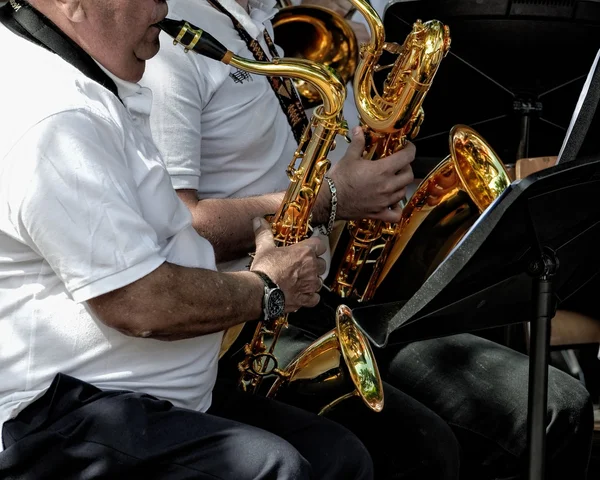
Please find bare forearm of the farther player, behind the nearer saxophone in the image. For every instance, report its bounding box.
[180,193,283,262]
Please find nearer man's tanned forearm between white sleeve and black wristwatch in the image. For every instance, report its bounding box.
[88,263,264,340]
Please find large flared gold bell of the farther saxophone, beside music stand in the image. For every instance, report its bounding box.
[375,125,511,302]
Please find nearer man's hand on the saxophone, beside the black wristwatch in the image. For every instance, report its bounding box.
[251,218,327,312]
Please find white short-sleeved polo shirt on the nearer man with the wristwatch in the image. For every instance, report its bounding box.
[0,25,222,442]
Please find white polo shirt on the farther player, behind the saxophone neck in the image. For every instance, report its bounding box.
[141,0,296,202]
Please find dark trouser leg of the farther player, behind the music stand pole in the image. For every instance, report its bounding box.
[291,304,593,480]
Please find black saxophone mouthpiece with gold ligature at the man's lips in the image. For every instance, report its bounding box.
[156,18,233,63]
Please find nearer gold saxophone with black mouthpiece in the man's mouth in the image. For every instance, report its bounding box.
[158,14,383,414]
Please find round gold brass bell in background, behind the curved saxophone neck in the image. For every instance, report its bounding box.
[272,5,358,108]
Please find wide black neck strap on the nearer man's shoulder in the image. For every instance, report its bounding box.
[0,0,119,97]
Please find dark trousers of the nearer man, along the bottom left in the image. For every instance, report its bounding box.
[0,374,373,480]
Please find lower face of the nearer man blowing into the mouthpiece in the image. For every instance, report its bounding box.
[78,0,168,82]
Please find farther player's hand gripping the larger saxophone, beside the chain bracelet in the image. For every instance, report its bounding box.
[322,127,415,222]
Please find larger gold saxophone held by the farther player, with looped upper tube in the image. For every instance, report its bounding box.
[327,5,510,303]
